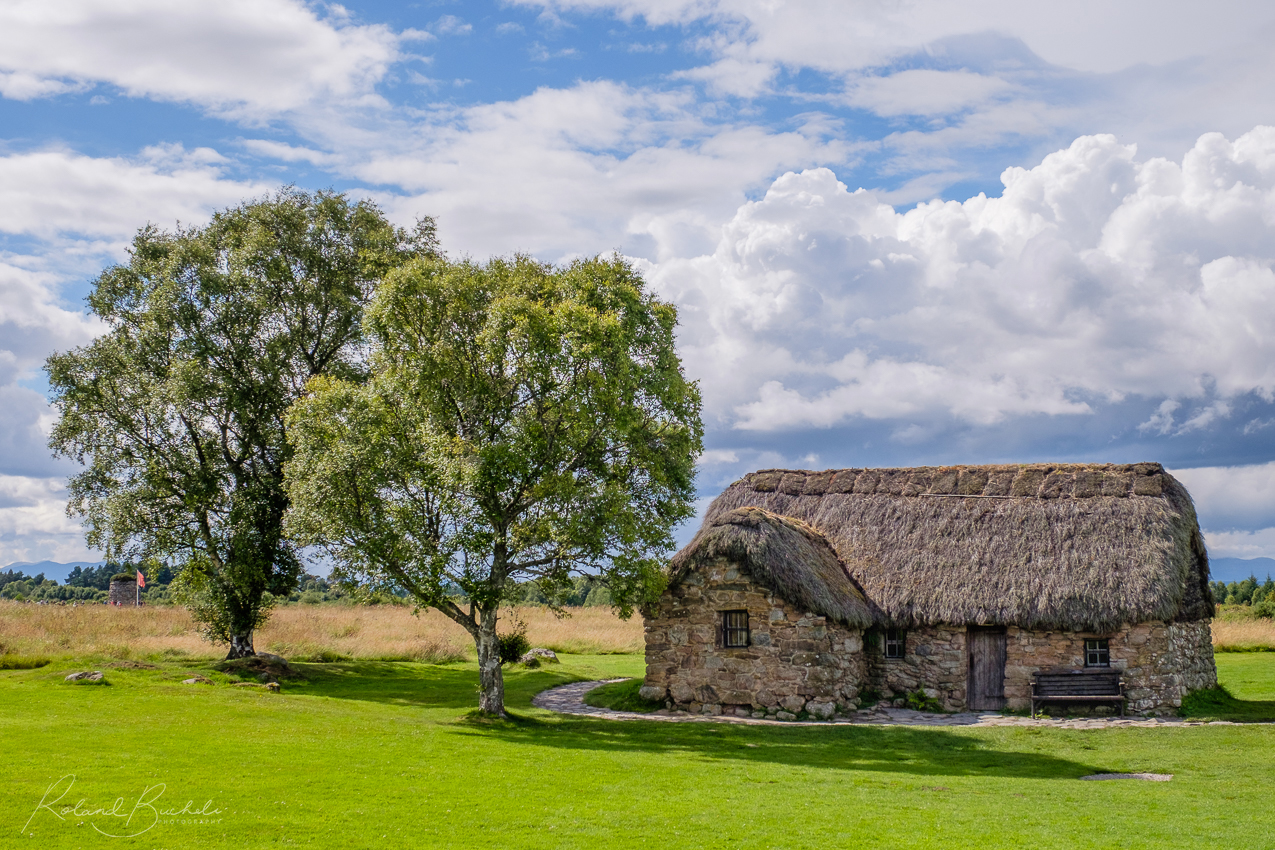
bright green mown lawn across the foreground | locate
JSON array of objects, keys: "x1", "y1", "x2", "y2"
[{"x1": 0, "y1": 652, "x2": 1275, "y2": 850}]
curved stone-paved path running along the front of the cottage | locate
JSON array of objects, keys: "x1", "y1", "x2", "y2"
[{"x1": 532, "y1": 678, "x2": 1253, "y2": 729}]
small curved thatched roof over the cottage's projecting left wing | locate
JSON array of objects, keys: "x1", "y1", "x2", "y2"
[{"x1": 669, "y1": 507, "x2": 873, "y2": 628}]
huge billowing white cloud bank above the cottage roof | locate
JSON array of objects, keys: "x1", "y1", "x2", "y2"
[{"x1": 648, "y1": 127, "x2": 1275, "y2": 433}]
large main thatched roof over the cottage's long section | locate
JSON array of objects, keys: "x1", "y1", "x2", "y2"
[{"x1": 705, "y1": 464, "x2": 1214, "y2": 632}]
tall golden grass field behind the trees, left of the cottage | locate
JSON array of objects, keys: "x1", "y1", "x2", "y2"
[{"x1": 0, "y1": 600, "x2": 643, "y2": 663}]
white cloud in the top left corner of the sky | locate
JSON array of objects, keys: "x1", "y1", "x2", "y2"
[{"x1": 0, "y1": 0, "x2": 402, "y2": 117}]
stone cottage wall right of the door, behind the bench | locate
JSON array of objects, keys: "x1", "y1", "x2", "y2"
[{"x1": 1005, "y1": 621, "x2": 1218, "y2": 715}]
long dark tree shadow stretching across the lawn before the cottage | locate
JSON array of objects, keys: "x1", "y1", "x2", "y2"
[{"x1": 456, "y1": 716, "x2": 1103, "y2": 779}]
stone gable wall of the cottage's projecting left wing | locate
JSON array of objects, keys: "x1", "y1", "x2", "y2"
[{"x1": 641, "y1": 559, "x2": 866, "y2": 719}]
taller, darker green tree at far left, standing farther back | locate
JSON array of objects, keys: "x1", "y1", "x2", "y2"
[{"x1": 46, "y1": 189, "x2": 436, "y2": 658}]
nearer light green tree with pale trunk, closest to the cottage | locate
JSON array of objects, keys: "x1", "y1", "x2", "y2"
[{"x1": 287, "y1": 251, "x2": 703, "y2": 715}]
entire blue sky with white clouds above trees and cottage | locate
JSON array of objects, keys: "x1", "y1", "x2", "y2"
[{"x1": 0, "y1": 0, "x2": 1275, "y2": 565}]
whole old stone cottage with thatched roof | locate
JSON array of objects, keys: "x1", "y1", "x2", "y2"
[{"x1": 644, "y1": 464, "x2": 1216, "y2": 715}]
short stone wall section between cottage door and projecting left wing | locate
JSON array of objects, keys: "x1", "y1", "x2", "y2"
[{"x1": 868, "y1": 626, "x2": 968, "y2": 711}]
